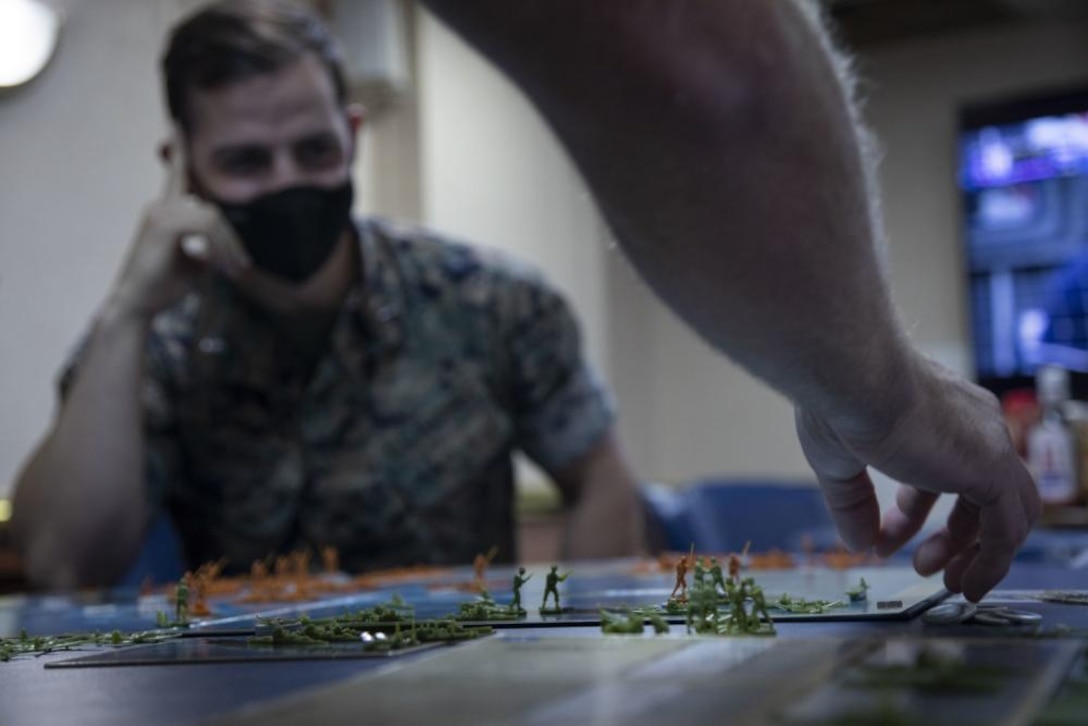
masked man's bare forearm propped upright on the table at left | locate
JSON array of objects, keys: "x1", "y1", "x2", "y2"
[{"x1": 12, "y1": 306, "x2": 153, "y2": 589}]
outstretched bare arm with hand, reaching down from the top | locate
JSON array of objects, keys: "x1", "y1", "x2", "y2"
[{"x1": 419, "y1": 0, "x2": 1039, "y2": 599}]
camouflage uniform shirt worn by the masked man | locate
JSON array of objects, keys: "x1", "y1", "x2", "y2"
[{"x1": 62, "y1": 220, "x2": 613, "y2": 570}]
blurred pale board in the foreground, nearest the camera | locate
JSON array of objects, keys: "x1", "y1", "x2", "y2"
[{"x1": 205, "y1": 631, "x2": 1084, "y2": 726}]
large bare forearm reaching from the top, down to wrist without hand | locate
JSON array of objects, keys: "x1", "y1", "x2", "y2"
[{"x1": 428, "y1": 0, "x2": 913, "y2": 428}]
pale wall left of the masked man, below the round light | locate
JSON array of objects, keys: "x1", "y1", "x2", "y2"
[{"x1": 0, "y1": 0, "x2": 173, "y2": 495}]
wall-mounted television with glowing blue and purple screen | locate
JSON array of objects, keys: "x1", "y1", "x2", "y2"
[{"x1": 959, "y1": 87, "x2": 1088, "y2": 397}]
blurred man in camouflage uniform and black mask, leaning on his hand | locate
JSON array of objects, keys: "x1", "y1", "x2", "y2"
[{"x1": 13, "y1": 0, "x2": 638, "y2": 588}]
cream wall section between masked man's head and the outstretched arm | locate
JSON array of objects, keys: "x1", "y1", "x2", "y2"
[{"x1": 417, "y1": 13, "x2": 607, "y2": 374}]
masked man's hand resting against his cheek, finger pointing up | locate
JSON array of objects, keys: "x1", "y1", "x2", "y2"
[{"x1": 111, "y1": 131, "x2": 251, "y2": 319}]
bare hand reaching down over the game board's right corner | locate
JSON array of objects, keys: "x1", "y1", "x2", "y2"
[{"x1": 796, "y1": 358, "x2": 1041, "y2": 602}]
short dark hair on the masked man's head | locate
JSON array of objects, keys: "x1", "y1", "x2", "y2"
[{"x1": 162, "y1": 0, "x2": 347, "y2": 130}]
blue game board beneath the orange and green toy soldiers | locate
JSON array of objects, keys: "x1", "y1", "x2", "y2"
[{"x1": 0, "y1": 561, "x2": 947, "y2": 636}]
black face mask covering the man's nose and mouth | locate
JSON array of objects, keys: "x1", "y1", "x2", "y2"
[{"x1": 215, "y1": 180, "x2": 355, "y2": 283}]
